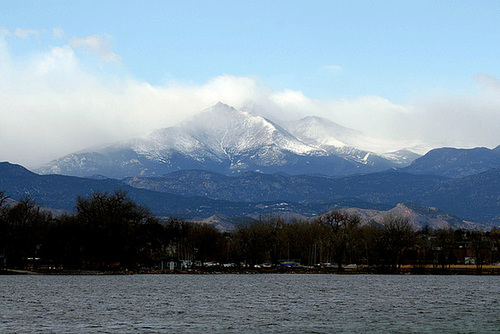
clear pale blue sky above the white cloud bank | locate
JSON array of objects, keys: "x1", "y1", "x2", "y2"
[{"x1": 4, "y1": 1, "x2": 500, "y2": 101}]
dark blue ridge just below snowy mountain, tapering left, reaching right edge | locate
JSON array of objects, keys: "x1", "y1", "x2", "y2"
[{"x1": 124, "y1": 167, "x2": 500, "y2": 222}]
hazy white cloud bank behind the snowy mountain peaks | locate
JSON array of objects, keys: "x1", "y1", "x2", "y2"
[{"x1": 0, "y1": 28, "x2": 500, "y2": 166}]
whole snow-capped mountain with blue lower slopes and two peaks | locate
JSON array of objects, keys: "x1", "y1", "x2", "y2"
[{"x1": 38, "y1": 103, "x2": 418, "y2": 178}]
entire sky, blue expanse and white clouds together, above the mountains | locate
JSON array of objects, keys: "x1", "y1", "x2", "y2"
[{"x1": 0, "y1": 0, "x2": 500, "y2": 164}]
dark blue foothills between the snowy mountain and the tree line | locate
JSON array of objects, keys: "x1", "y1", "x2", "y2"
[{"x1": 0, "y1": 163, "x2": 500, "y2": 227}]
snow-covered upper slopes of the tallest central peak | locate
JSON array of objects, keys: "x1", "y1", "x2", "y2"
[{"x1": 133, "y1": 102, "x2": 318, "y2": 159}]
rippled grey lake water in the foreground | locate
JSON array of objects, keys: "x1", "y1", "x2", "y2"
[{"x1": 0, "y1": 274, "x2": 500, "y2": 334}]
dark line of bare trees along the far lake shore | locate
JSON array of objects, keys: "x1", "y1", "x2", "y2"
[{"x1": 0, "y1": 191, "x2": 500, "y2": 272}]
